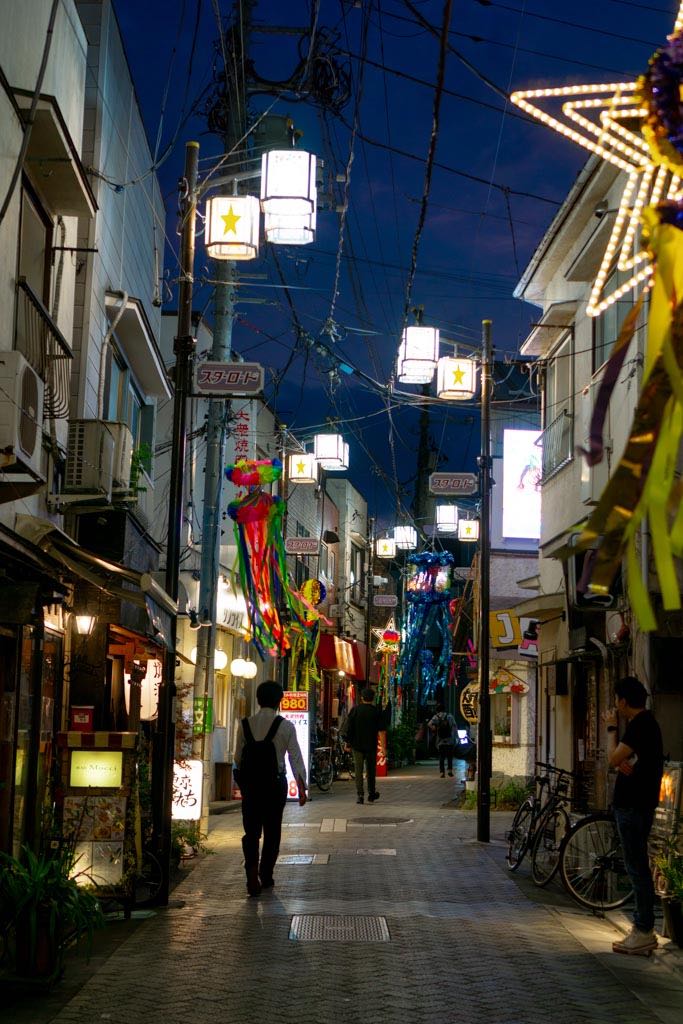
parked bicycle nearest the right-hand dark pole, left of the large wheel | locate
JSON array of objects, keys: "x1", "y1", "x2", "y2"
[{"x1": 506, "y1": 761, "x2": 572, "y2": 885}]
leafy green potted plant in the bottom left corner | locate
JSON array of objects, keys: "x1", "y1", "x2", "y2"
[{"x1": 0, "y1": 845, "x2": 104, "y2": 981}]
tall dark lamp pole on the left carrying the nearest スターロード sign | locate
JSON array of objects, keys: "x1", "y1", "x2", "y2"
[{"x1": 152, "y1": 142, "x2": 200, "y2": 905}]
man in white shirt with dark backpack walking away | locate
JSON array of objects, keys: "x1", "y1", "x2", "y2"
[{"x1": 233, "y1": 680, "x2": 306, "y2": 896}]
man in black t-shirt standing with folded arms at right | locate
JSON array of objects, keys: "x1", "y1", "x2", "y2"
[{"x1": 605, "y1": 676, "x2": 664, "y2": 953}]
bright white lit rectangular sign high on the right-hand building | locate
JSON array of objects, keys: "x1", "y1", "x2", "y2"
[{"x1": 503, "y1": 430, "x2": 542, "y2": 541}]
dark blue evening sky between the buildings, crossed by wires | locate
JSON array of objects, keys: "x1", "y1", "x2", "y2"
[{"x1": 115, "y1": 0, "x2": 678, "y2": 515}]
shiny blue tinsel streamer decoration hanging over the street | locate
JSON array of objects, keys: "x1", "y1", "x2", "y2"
[{"x1": 397, "y1": 551, "x2": 454, "y2": 697}]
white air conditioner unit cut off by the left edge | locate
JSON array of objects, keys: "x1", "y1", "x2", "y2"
[{"x1": 0, "y1": 352, "x2": 45, "y2": 480}]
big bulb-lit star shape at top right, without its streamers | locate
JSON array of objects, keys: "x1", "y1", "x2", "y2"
[{"x1": 510, "y1": 2, "x2": 683, "y2": 316}]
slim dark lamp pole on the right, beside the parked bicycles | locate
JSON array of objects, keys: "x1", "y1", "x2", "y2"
[{"x1": 477, "y1": 321, "x2": 492, "y2": 843}]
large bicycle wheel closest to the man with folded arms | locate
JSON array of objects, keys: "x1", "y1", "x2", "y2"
[{"x1": 560, "y1": 814, "x2": 633, "y2": 910}]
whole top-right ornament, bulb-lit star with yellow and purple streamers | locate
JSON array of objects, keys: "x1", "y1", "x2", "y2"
[{"x1": 511, "y1": 3, "x2": 683, "y2": 631}]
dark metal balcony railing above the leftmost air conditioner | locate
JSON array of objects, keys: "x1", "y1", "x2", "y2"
[{"x1": 14, "y1": 278, "x2": 74, "y2": 420}]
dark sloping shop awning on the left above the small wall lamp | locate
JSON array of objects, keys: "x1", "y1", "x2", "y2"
[{"x1": 15, "y1": 515, "x2": 178, "y2": 647}]
